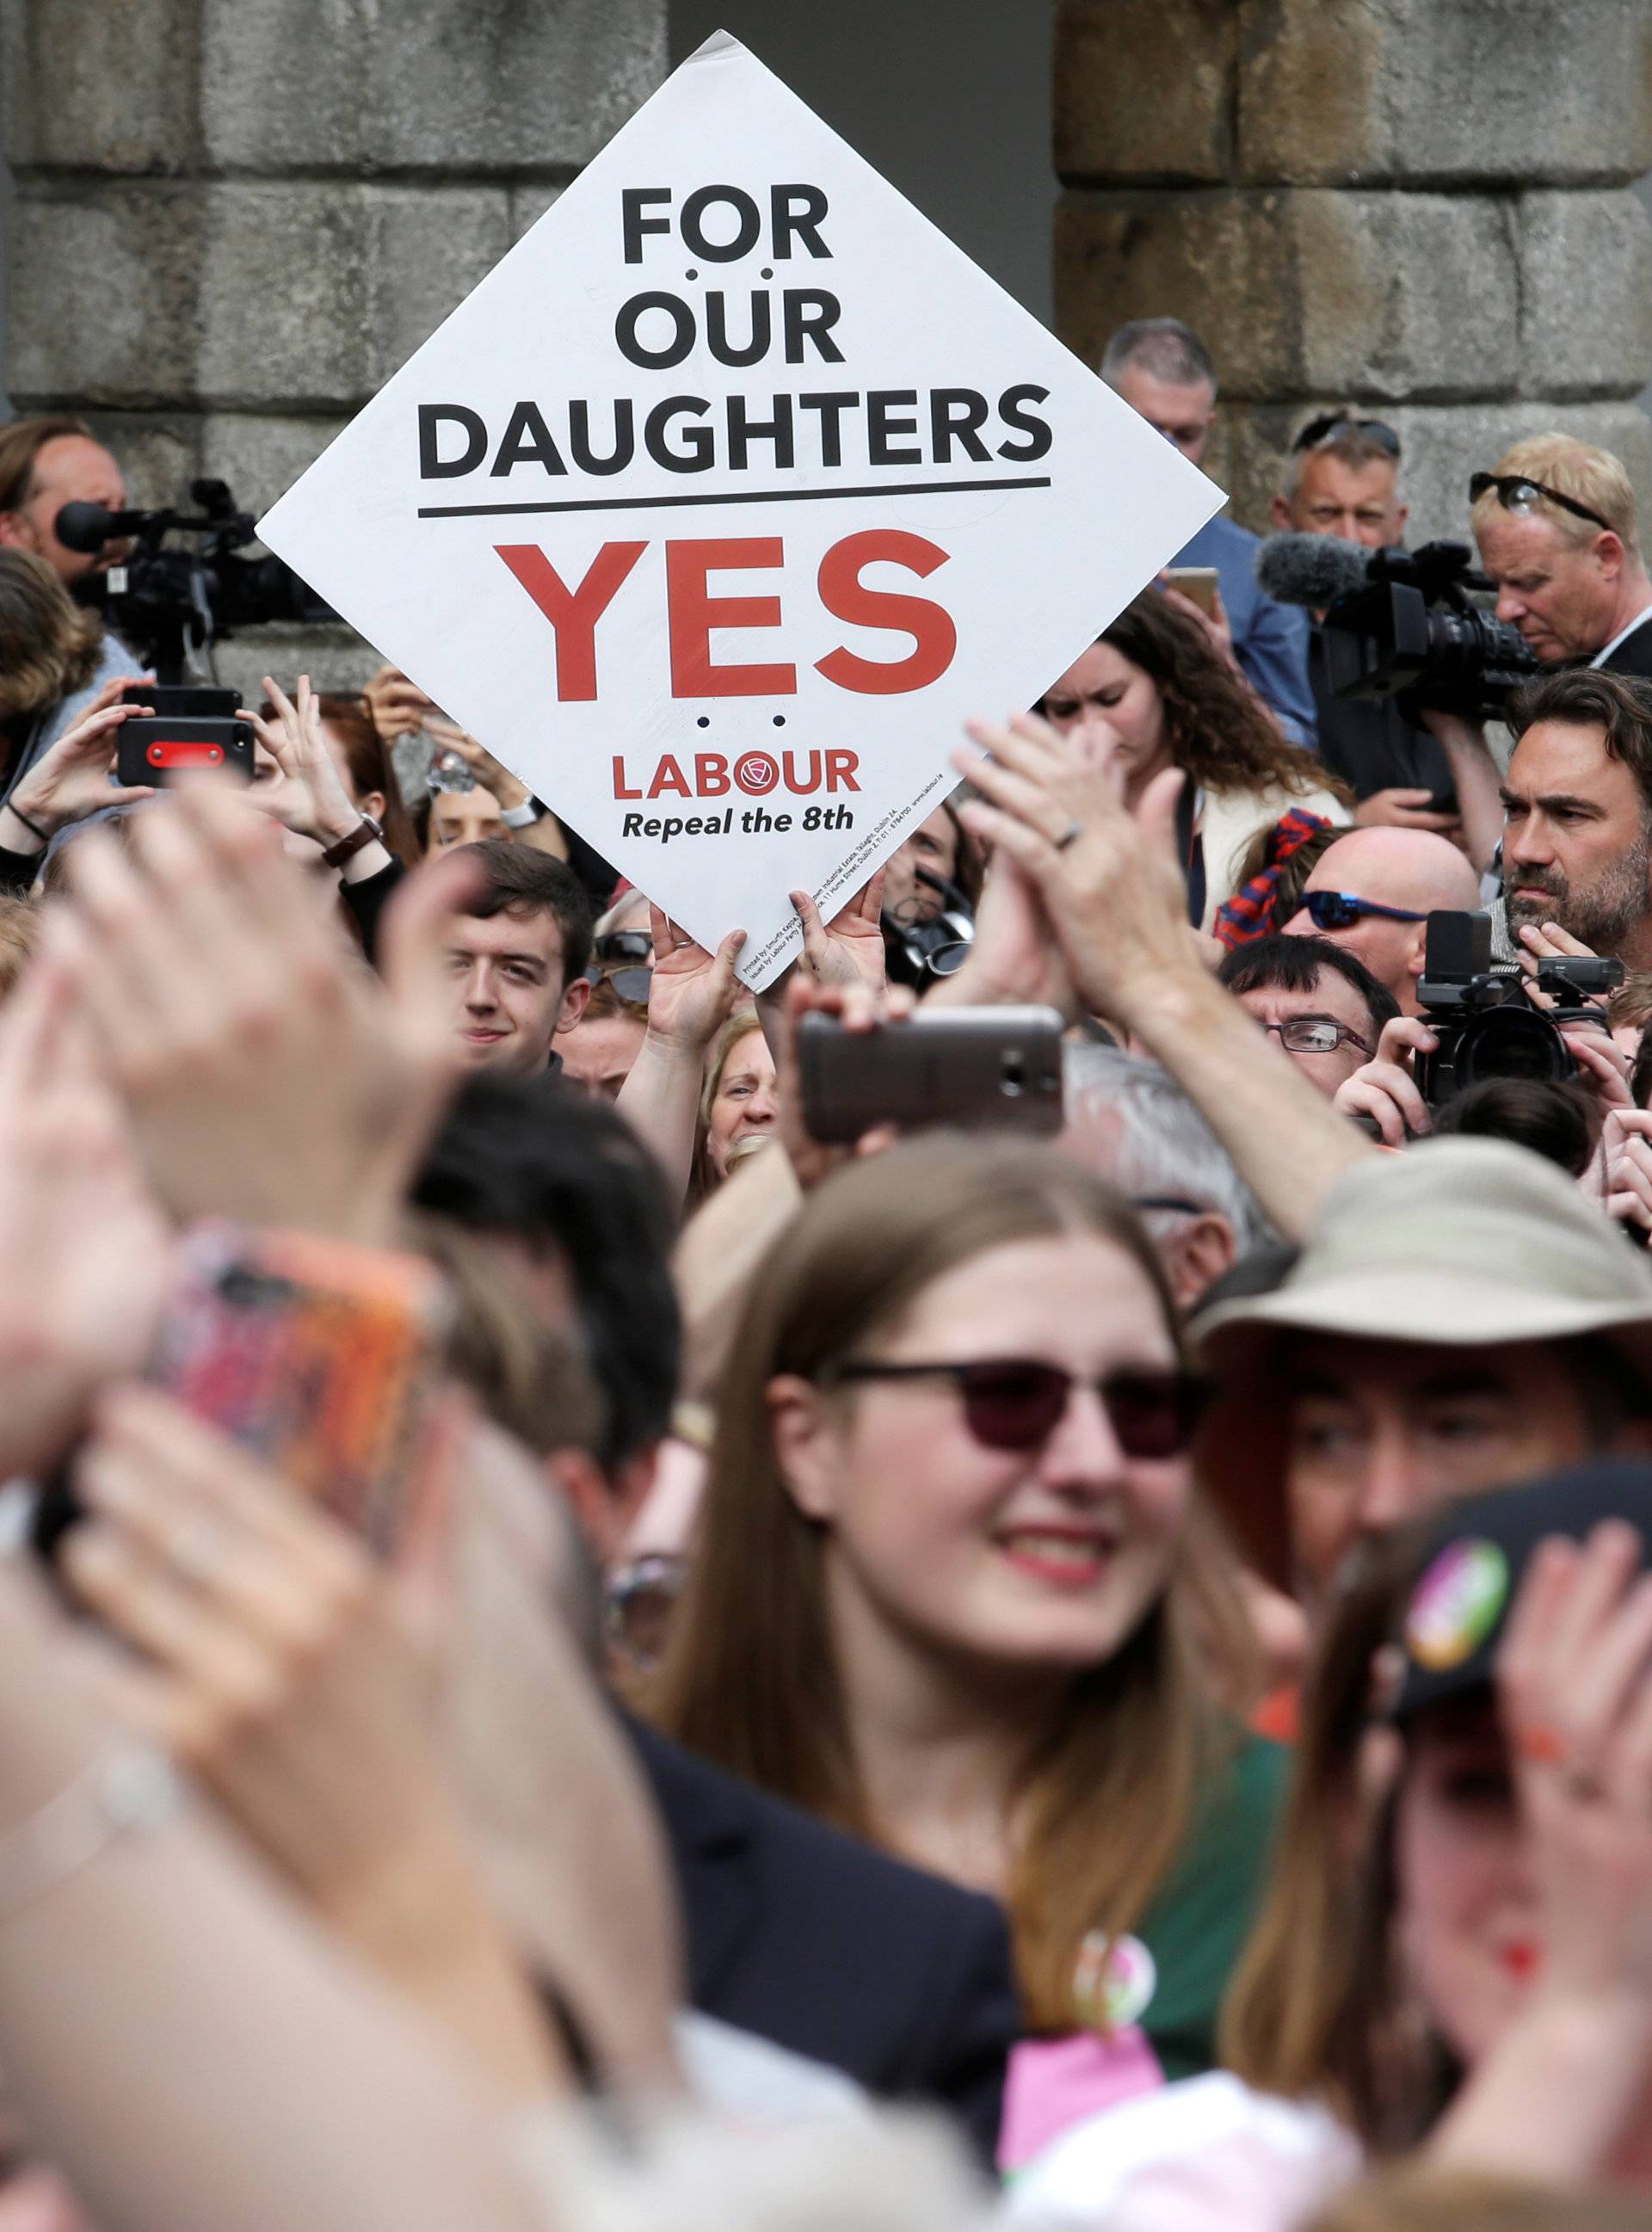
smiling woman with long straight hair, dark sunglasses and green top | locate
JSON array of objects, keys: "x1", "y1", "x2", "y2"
[{"x1": 654, "y1": 1134, "x2": 1279, "y2": 2163}]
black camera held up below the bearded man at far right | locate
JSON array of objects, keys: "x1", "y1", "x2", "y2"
[{"x1": 1415, "y1": 909, "x2": 1623, "y2": 1107}]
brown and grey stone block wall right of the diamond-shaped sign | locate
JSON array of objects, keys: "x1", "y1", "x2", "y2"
[{"x1": 1056, "y1": 0, "x2": 1652, "y2": 538}]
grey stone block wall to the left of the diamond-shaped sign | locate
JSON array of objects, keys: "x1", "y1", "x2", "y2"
[{"x1": 0, "y1": 0, "x2": 668, "y2": 687}]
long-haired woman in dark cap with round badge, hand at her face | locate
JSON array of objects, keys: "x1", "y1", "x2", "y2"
[{"x1": 1018, "y1": 1459, "x2": 1652, "y2": 2232}]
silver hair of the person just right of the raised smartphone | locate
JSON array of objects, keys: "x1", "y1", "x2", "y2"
[{"x1": 1060, "y1": 1042, "x2": 1275, "y2": 1255}]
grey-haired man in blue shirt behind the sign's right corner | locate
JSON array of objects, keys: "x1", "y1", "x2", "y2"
[{"x1": 1100, "y1": 317, "x2": 1315, "y2": 750}]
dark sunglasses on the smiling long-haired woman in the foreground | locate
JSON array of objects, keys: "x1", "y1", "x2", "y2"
[{"x1": 833, "y1": 1357, "x2": 1208, "y2": 1458}]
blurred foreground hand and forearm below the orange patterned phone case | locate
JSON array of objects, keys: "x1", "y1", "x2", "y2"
[{"x1": 63, "y1": 1386, "x2": 556, "y2": 2093}]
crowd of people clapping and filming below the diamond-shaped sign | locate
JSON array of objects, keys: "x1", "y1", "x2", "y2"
[{"x1": 0, "y1": 287, "x2": 1652, "y2": 2232}]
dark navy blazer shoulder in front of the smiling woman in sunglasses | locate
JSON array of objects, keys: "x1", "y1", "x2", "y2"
[{"x1": 627, "y1": 1721, "x2": 1020, "y2": 2161}]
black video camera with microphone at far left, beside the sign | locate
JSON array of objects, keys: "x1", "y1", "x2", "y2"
[{"x1": 53, "y1": 480, "x2": 337, "y2": 683}]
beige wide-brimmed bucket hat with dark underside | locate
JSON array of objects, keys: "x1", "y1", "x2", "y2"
[{"x1": 1190, "y1": 1138, "x2": 1652, "y2": 1585}]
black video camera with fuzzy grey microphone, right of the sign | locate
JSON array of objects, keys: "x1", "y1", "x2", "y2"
[{"x1": 1257, "y1": 536, "x2": 1540, "y2": 725}]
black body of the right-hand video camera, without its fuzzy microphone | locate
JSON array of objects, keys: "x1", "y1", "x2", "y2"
[{"x1": 1324, "y1": 542, "x2": 1540, "y2": 725}]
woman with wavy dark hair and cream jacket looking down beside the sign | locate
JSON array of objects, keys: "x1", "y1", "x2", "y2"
[{"x1": 1038, "y1": 589, "x2": 1353, "y2": 931}]
